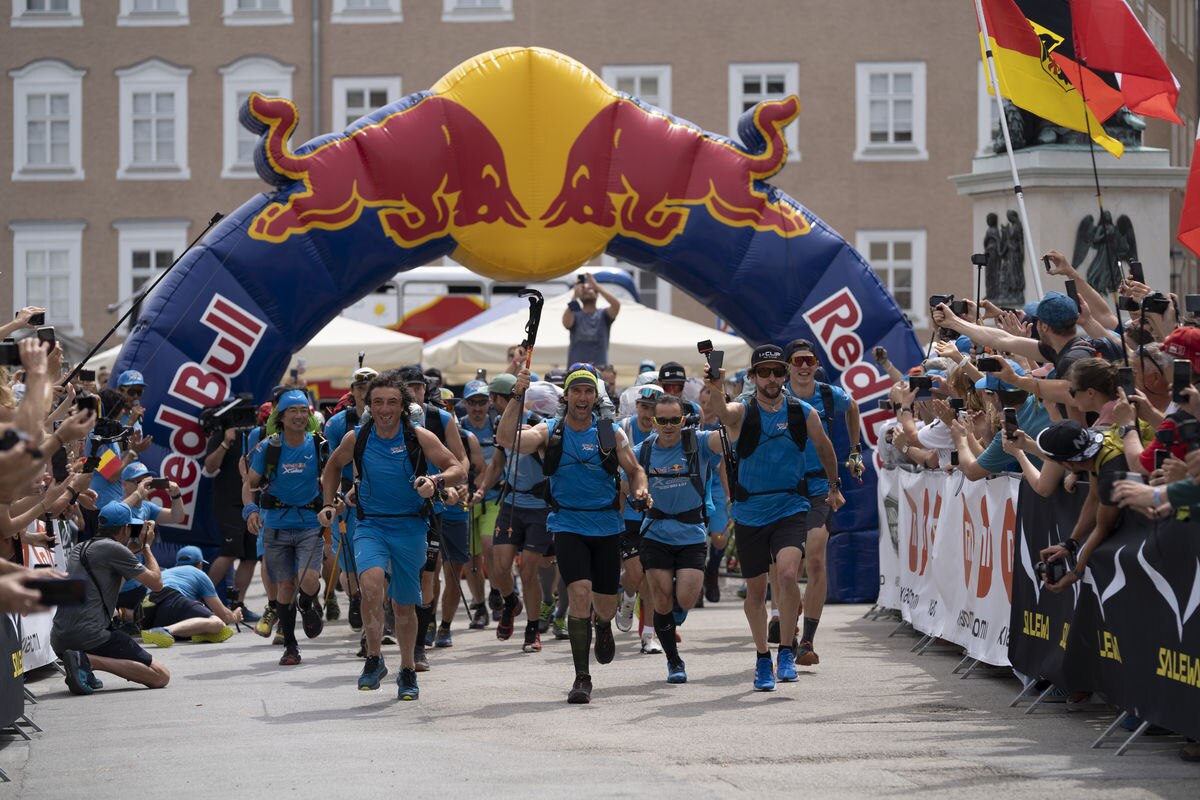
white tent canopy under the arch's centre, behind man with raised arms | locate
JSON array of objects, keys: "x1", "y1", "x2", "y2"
[{"x1": 425, "y1": 291, "x2": 751, "y2": 386}]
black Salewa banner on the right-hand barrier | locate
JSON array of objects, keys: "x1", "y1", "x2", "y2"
[{"x1": 1008, "y1": 486, "x2": 1200, "y2": 739}]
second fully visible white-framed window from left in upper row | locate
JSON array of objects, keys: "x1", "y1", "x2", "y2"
[{"x1": 116, "y1": 59, "x2": 192, "y2": 180}]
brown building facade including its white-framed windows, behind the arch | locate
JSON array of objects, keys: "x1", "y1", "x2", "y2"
[{"x1": 0, "y1": 0, "x2": 1198, "y2": 341}]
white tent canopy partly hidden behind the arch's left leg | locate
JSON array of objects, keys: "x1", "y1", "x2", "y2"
[{"x1": 88, "y1": 317, "x2": 424, "y2": 385}]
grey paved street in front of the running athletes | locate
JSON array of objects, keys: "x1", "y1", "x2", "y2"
[{"x1": 0, "y1": 584, "x2": 1200, "y2": 800}]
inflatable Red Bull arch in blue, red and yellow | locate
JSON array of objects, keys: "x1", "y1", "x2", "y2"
[{"x1": 113, "y1": 48, "x2": 920, "y2": 545}]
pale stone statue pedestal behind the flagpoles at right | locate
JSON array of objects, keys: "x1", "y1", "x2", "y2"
[{"x1": 950, "y1": 144, "x2": 1188, "y2": 300}]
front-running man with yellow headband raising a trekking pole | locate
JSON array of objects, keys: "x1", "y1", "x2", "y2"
[{"x1": 496, "y1": 368, "x2": 650, "y2": 703}]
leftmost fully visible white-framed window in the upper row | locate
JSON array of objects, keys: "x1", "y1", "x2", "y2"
[{"x1": 8, "y1": 60, "x2": 86, "y2": 181}]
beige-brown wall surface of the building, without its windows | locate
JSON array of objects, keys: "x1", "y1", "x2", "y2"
[{"x1": 0, "y1": 0, "x2": 1196, "y2": 341}]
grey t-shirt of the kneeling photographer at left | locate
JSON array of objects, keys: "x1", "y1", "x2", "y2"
[{"x1": 50, "y1": 539, "x2": 145, "y2": 652}]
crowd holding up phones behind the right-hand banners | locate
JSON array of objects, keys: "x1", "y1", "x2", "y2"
[{"x1": 875, "y1": 251, "x2": 1200, "y2": 760}]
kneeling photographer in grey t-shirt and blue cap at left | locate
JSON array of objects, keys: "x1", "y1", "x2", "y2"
[{"x1": 50, "y1": 503, "x2": 170, "y2": 694}]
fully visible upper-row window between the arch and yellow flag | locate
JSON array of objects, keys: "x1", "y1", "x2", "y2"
[{"x1": 854, "y1": 61, "x2": 929, "y2": 161}]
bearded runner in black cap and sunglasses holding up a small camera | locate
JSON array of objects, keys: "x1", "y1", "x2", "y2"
[{"x1": 706, "y1": 344, "x2": 845, "y2": 691}]
